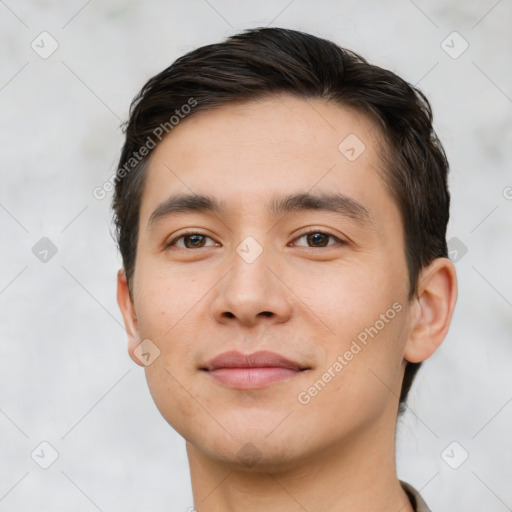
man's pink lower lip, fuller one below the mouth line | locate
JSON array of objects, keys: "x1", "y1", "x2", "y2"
[{"x1": 208, "y1": 367, "x2": 301, "y2": 389}]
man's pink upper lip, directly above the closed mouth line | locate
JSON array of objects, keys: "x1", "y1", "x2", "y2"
[{"x1": 202, "y1": 350, "x2": 305, "y2": 371}]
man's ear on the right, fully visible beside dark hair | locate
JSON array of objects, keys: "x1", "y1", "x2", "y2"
[{"x1": 404, "y1": 258, "x2": 457, "y2": 363}]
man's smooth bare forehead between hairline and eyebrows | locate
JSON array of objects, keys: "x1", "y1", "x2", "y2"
[{"x1": 140, "y1": 95, "x2": 392, "y2": 230}]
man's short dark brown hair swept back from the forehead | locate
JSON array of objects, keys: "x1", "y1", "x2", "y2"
[{"x1": 112, "y1": 28, "x2": 450, "y2": 412}]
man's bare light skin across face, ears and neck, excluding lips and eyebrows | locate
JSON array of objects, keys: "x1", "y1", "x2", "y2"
[{"x1": 117, "y1": 95, "x2": 457, "y2": 512}]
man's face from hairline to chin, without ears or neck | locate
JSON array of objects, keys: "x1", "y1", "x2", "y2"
[{"x1": 124, "y1": 96, "x2": 411, "y2": 467}]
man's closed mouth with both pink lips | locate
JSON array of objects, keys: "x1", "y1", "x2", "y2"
[{"x1": 200, "y1": 351, "x2": 310, "y2": 389}]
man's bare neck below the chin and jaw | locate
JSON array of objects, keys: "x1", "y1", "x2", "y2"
[{"x1": 187, "y1": 412, "x2": 414, "y2": 512}]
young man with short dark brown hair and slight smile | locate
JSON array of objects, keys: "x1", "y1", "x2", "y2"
[{"x1": 113, "y1": 28, "x2": 457, "y2": 512}]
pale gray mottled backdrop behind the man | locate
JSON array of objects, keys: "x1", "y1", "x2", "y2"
[{"x1": 0, "y1": 0, "x2": 512, "y2": 512}]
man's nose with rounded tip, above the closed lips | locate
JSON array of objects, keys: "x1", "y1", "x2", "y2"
[{"x1": 211, "y1": 241, "x2": 293, "y2": 327}]
